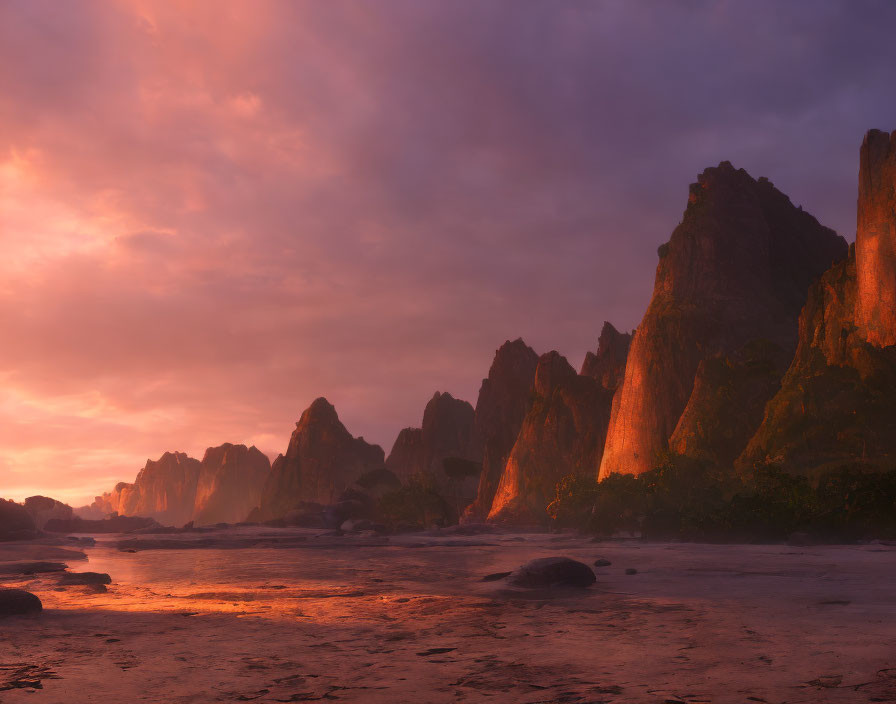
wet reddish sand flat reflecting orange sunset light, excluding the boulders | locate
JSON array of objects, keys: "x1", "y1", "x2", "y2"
[{"x1": 0, "y1": 529, "x2": 896, "y2": 704}]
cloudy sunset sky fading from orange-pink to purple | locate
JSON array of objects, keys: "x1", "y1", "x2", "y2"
[{"x1": 0, "y1": 0, "x2": 896, "y2": 505}]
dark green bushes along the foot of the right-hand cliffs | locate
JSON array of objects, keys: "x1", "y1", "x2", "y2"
[{"x1": 548, "y1": 454, "x2": 896, "y2": 542}]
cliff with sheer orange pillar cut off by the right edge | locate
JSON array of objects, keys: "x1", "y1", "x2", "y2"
[{"x1": 738, "y1": 130, "x2": 896, "y2": 474}]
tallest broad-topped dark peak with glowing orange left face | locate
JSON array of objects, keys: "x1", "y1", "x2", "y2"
[{"x1": 600, "y1": 162, "x2": 847, "y2": 477}]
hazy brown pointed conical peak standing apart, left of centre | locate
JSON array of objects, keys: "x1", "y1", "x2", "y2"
[{"x1": 252, "y1": 398, "x2": 384, "y2": 520}]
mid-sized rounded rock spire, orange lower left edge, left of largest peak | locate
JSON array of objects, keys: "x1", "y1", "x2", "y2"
[{"x1": 488, "y1": 352, "x2": 612, "y2": 523}]
